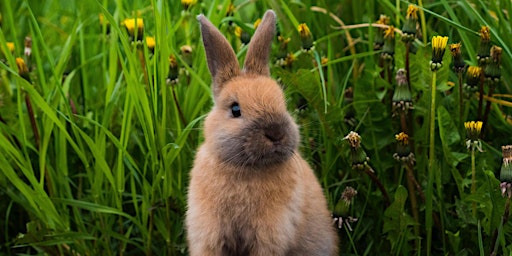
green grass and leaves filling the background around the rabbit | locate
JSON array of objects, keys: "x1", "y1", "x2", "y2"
[{"x1": 0, "y1": 0, "x2": 512, "y2": 255}]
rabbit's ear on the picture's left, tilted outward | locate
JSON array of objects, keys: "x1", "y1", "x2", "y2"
[{"x1": 197, "y1": 14, "x2": 240, "y2": 98}]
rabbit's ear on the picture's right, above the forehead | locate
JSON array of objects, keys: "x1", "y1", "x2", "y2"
[{"x1": 244, "y1": 10, "x2": 276, "y2": 76}]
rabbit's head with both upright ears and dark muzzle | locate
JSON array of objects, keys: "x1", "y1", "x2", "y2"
[{"x1": 198, "y1": 11, "x2": 299, "y2": 169}]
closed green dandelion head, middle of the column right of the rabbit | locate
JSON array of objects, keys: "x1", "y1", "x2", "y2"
[{"x1": 392, "y1": 68, "x2": 413, "y2": 115}]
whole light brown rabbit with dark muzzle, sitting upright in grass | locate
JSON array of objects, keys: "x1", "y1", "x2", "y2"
[{"x1": 186, "y1": 11, "x2": 338, "y2": 256}]
